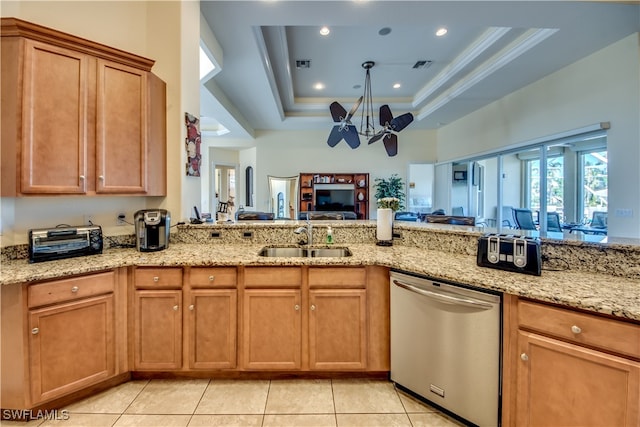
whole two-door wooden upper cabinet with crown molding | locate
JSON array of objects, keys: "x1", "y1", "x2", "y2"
[{"x1": 0, "y1": 18, "x2": 166, "y2": 197}]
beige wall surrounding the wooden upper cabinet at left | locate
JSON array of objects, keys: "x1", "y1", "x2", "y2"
[{"x1": 0, "y1": 0, "x2": 200, "y2": 246}]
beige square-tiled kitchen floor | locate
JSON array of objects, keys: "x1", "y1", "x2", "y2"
[{"x1": 1, "y1": 379, "x2": 460, "y2": 427}]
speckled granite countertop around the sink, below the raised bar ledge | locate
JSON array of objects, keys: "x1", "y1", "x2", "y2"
[{"x1": 0, "y1": 243, "x2": 640, "y2": 321}]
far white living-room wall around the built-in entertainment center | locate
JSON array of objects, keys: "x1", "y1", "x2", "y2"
[{"x1": 235, "y1": 129, "x2": 436, "y2": 217}]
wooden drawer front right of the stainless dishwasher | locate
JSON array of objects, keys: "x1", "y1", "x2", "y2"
[{"x1": 518, "y1": 301, "x2": 640, "y2": 358}]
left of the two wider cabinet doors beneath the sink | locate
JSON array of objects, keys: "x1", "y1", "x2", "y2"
[{"x1": 242, "y1": 289, "x2": 302, "y2": 369}]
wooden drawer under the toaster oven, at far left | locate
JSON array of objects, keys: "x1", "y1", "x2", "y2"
[{"x1": 27, "y1": 271, "x2": 115, "y2": 308}]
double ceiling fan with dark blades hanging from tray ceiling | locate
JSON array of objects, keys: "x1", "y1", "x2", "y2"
[{"x1": 327, "y1": 61, "x2": 413, "y2": 157}]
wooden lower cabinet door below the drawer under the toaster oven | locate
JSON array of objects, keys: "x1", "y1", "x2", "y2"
[{"x1": 29, "y1": 294, "x2": 115, "y2": 403}]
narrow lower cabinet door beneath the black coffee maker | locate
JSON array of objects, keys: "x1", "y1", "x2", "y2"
[{"x1": 134, "y1": 290, "x2": 182, "y2": 370}]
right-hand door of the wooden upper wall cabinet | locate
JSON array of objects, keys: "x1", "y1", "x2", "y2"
[{"x1": 96, "y1": 60, "x2": 148, "y2": 193}]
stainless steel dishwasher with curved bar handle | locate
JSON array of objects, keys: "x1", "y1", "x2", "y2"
[{"x1": 390, "y1": 272, "x2": 502, "y2": 427}]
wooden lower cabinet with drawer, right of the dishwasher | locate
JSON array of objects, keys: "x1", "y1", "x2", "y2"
[{"x1": 502, "y1": 295, "x2": 640, "y2": 427}]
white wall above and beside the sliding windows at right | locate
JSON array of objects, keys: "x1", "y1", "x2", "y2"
[{"x1": 437, "y1": 34, "x2": 640, "y2": 238}]
